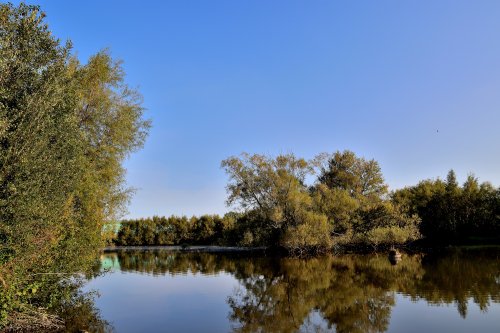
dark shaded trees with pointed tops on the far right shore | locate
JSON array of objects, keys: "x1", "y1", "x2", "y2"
[{"x1": 392, "y1": 170, "x2": 500, "y2": 243}]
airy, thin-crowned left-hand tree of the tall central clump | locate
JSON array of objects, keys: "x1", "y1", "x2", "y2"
[{"x1": 222, "y1": 154, "x2": 330, "y2": 252}]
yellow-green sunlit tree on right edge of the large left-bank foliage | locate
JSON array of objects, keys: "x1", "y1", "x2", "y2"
[{"x1": 70, "y1": 50, "x2": 150, "y2": 220}]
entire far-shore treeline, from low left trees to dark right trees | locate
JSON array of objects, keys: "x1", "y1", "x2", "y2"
[{"x1": 114, "y1": 151, "x2": 500, "y2": 253}]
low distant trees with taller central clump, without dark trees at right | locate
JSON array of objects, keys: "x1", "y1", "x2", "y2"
[{"x1": 115, "y1": 151, "x2": 420, "y2": 253}]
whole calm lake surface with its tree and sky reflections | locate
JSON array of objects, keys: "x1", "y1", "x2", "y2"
[{"x1": 87, "y1": 248, "x2": 500, "y2": 333}]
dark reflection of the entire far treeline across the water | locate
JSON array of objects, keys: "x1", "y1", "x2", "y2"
[{"x1": 107, "y1": 250, "x2": 500, "y2": 332}]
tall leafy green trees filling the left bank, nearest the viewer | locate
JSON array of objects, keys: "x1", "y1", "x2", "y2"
[{"x1": 0, "y1": 4, "x2": 149, "y2": 329}]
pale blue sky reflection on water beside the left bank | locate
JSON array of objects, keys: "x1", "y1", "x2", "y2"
[{"x1": 86, "y1": 272, "x2": 237, "y2": 333}]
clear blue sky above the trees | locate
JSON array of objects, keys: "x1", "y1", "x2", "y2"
[{"x1": 14, "y1": 0, "x2": 500, "y2": 217}]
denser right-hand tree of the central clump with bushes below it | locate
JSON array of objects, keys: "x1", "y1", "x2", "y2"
[{"x1": 311, "y1": 151, "x2": 420, "y2": 246}]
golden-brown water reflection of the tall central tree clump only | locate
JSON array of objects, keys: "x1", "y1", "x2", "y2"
[{"x1": 228, "y1": 256, "x2": 418, "y2": 332}]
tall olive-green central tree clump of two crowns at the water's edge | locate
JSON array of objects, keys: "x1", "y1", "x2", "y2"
[{"x1": 222, "y1": 151, "x2": 420, "y2": 253}]
